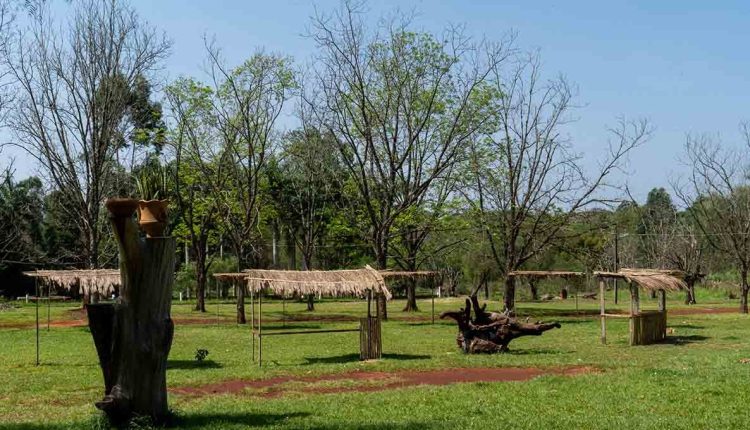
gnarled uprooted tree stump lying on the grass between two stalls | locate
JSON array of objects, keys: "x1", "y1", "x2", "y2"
[{"x1": 440, "y1": 296, "x2": 560, "y2": 354}]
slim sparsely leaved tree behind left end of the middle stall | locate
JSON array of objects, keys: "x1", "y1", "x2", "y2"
[{"x1": 206, "y1": 44, "x2": 297, "y2": 324}]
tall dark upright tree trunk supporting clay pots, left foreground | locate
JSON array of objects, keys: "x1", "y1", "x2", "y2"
[{"x1": 89, "y1": 202, "x2": 175, "y2": 422}]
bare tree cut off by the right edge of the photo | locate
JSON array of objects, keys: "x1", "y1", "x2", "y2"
[{"x1": 675, "y1": 127, "x2": 750, "y2": 313}]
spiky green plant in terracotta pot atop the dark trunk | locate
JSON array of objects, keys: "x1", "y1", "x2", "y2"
[{"x1": 135, "y1": 166, "x2": 169, "y2": 237}]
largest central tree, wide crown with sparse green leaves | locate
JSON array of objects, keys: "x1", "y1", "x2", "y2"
[{"x1": 310, "y1": 2, "x2": 508, "y2": 318}]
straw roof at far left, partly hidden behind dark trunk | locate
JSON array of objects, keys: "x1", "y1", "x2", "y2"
[{"x1": 23, "y1": 269, "x2": 121, "y2": 295}]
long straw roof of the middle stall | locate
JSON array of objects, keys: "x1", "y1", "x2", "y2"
[{"x1": 214, "y1": 266, "x2": 392, "y2": 299}]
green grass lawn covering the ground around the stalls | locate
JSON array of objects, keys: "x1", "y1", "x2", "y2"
[{"x1": 0, "y1": 292, "x2": 750, "y2": 430}]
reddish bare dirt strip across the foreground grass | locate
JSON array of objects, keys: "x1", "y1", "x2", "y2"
[{"x1": 170, "y1": 366, "x2": 597, "y2": 398}]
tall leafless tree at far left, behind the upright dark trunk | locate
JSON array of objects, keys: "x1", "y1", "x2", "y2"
[{"x1": 2, "y1": 0, "x2": 170, "y2": 267}]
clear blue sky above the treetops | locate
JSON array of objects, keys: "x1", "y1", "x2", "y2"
[{"x1": 2, "y1": 0, "x2": 750, "y2": 200}]
